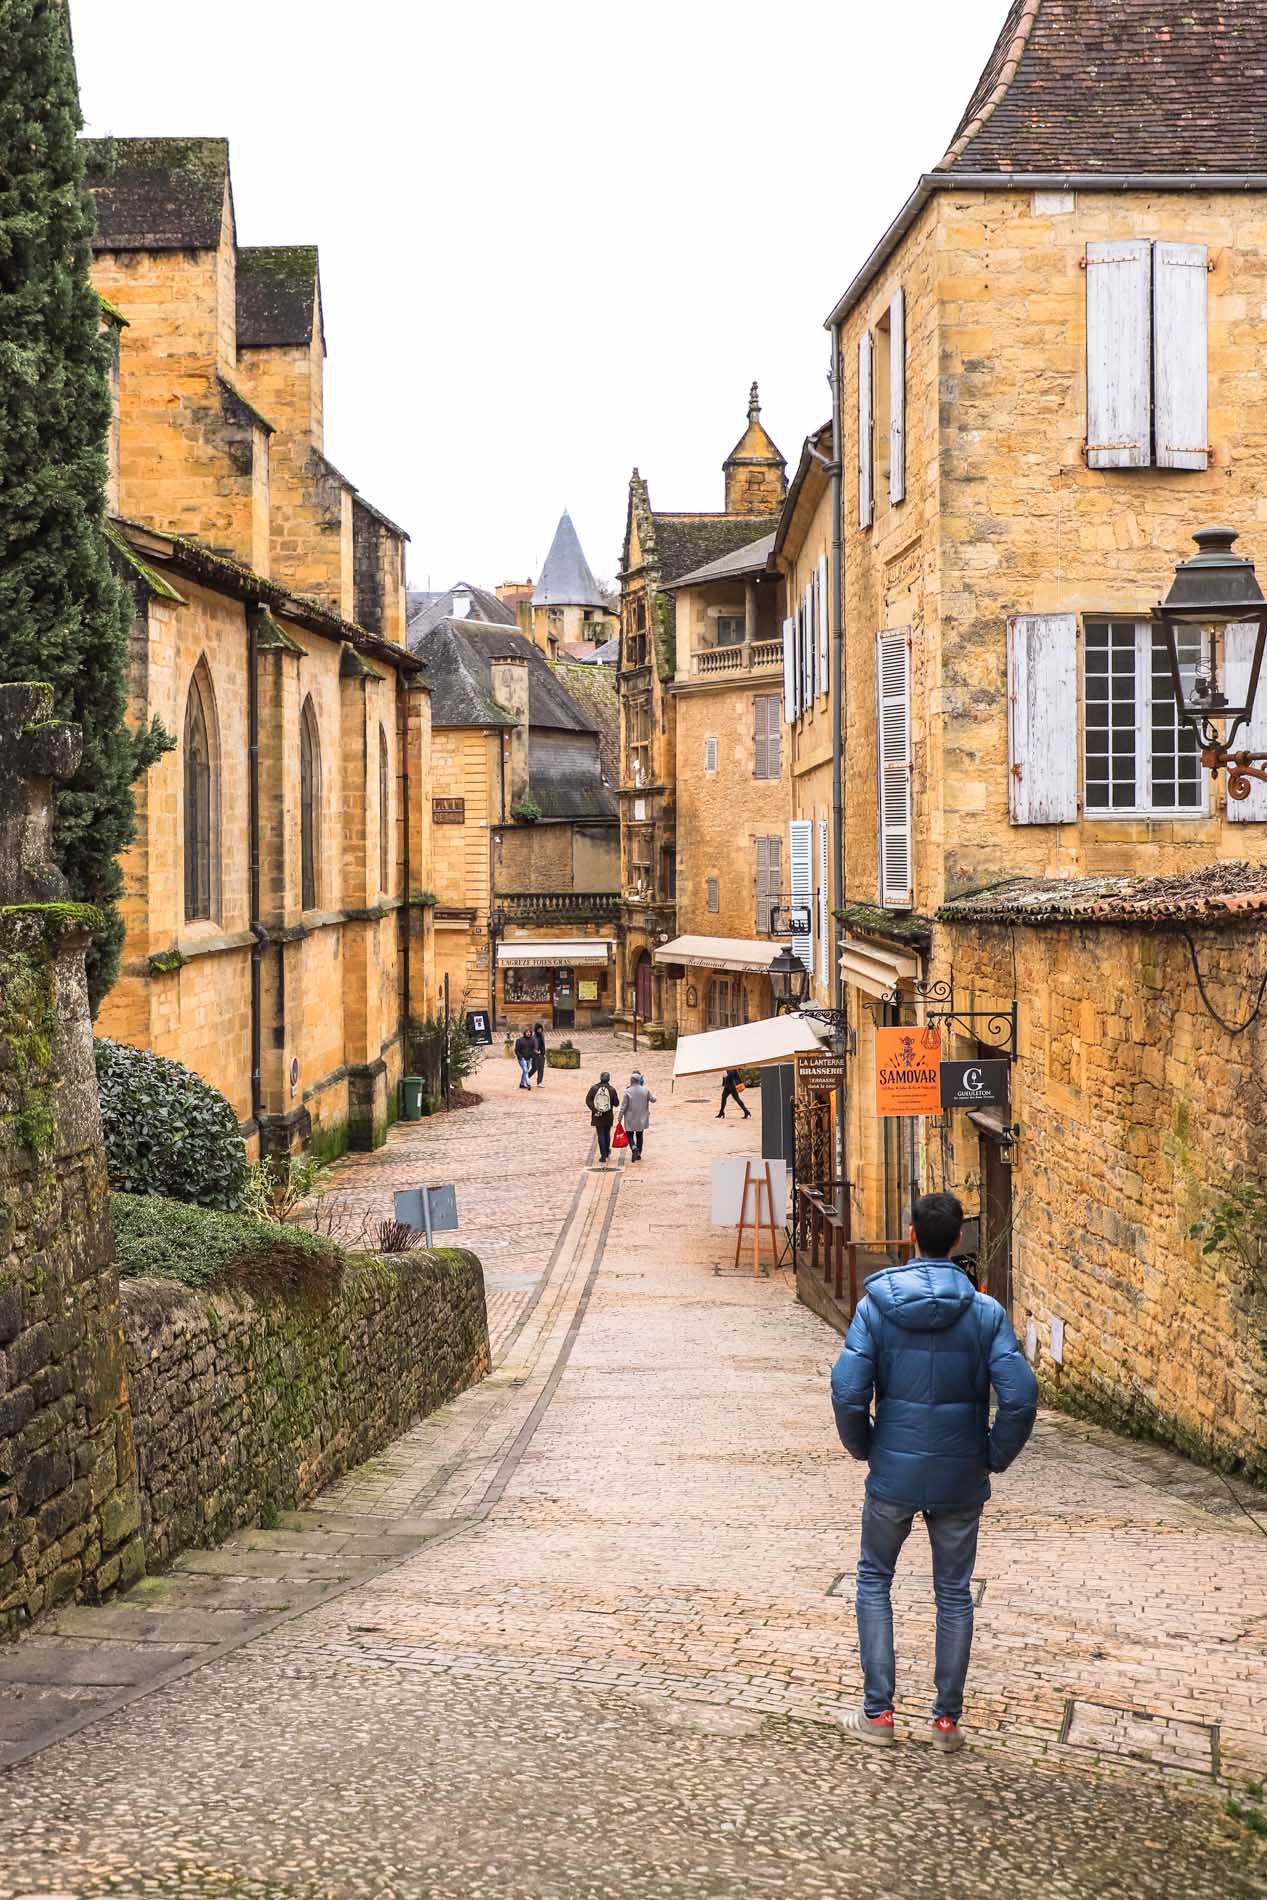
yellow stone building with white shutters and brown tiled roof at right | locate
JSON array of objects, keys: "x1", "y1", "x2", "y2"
[{"x1": 816, "y1": 0, "x2": 1267, "y2": 1467}]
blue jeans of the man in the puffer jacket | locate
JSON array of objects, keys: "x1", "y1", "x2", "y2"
[{"x1": 855, "y1": 1493, "x2": 982, "y2": 1721}]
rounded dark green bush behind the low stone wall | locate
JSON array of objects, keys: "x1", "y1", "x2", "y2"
[{"x1": 93, "y1": 1036, "x2": 247, "y2": 1208}]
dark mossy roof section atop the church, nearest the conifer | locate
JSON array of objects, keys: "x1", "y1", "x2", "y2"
[{"x1": 84, "y1": 139, "x2": 228, "y2": 251}]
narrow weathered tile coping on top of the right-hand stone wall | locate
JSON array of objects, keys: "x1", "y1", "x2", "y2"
[{"x1": 938, "y1": 859, "x2": 1267, "y2": 925}]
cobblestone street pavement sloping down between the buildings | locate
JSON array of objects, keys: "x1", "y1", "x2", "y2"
[{"x1": 0, "y1": 1037, "x2": 1267, "y2": 1900}]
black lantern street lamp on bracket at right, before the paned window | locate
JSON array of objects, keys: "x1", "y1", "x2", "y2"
[{"x1": 1153, "y1": 528, "x2": 1267, "y2": 800}]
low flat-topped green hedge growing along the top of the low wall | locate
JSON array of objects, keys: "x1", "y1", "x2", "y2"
[{"x1": 110, "y1": 1193, "x2": 346, "y2": 1292}]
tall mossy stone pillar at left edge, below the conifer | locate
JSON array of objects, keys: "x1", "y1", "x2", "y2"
[{"x1": 0, "y1": 686, "x2": 144, "y2": 1636}]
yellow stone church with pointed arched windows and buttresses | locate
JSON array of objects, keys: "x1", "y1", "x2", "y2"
[{"x1": 87, "y1": 139, "x2": 431, "y2": 1153}]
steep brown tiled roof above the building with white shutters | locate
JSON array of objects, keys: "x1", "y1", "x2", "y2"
[{"x1": 938, "y1": 0, "x2": 1267, "y2": 173}]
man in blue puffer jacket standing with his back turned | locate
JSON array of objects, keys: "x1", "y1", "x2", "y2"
[{"x1": 832, "y1": 1193, "x2": 1039, "y2": 1752}]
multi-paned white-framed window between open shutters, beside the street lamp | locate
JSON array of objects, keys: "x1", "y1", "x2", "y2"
[{"x1": 1083, "y1": 619, "x2": 1206, "y2": 817}]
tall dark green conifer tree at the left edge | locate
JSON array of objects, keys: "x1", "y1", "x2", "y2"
[{"x1": 0, "y1": 0, "x2": 169, "y2": 1009}]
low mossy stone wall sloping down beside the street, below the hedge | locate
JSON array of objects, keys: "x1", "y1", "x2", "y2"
[{"x1": 122, "y1": 1252, "x2": 488, "y2": 1568}]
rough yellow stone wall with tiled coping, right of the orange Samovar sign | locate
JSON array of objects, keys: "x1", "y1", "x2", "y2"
[{"x1": 927, "y1": 923, "x2": 1267, "y2": 1476}]
